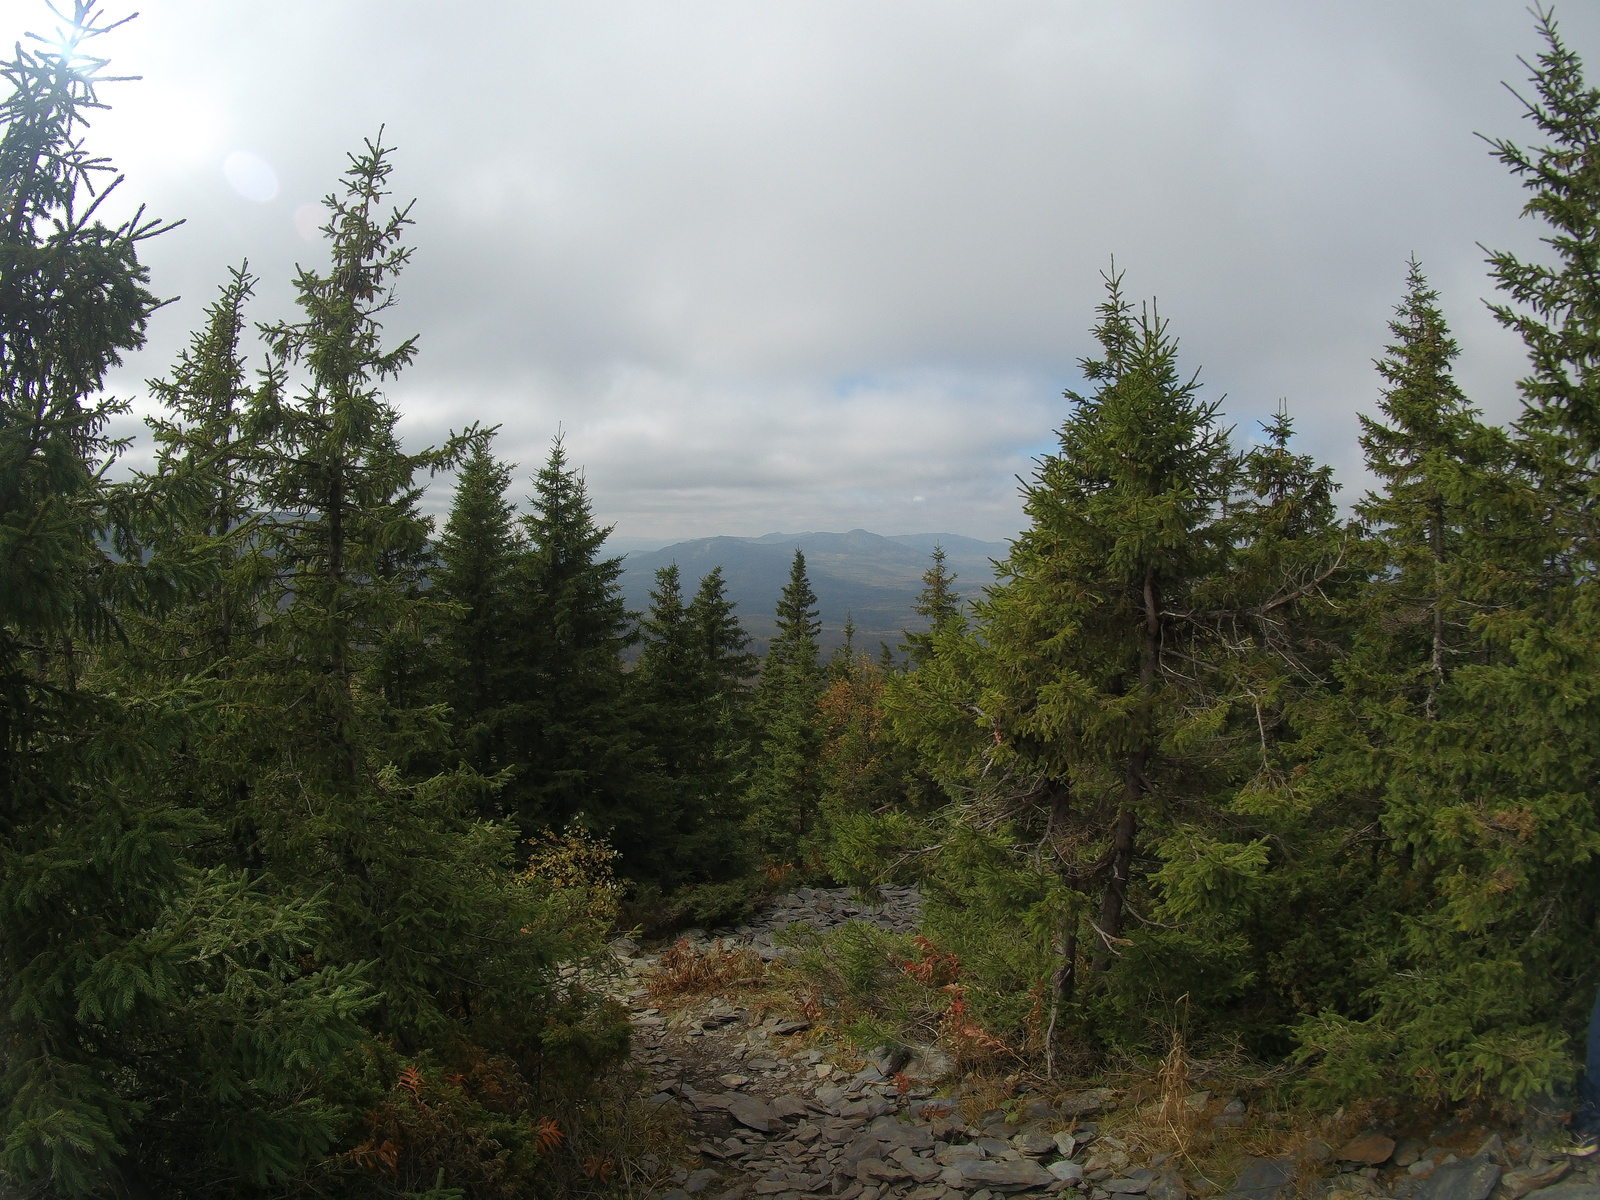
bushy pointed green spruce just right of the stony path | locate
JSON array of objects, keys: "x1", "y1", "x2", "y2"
[{"x1": 979, "y1": 275, "x2": 1235, "y2": 970}]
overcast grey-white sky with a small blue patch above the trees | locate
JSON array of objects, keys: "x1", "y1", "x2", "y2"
[{"x1": 21, "y1": 0, "x2": 1600, "y2": 541}]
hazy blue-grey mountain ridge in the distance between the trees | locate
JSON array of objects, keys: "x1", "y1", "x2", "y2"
[{"x1": 622, "y1": 530, "x2": 1010, "y2": 653}]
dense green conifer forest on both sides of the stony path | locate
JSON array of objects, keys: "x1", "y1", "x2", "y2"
[{"x1": 15, "y1": 0, "x2": 1600, "y2": 1200}]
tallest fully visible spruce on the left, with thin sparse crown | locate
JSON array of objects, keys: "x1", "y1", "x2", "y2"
[{"x1": 218, "y1": 142, "x2": 576, "y2": 1094}]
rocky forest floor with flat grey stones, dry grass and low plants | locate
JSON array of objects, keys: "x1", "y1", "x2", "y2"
[{"x1": 613, "y1": 888, "x2": 1600, "y2": 1200}]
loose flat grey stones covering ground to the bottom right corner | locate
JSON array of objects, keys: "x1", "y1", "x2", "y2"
[{"x1": 601, "y1": 888, "x2": 1600, "y2": 1200}]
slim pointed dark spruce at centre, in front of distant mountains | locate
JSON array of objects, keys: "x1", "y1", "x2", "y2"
[{"x1": 749, "y1": 550, "x2": 822, "y2": 862}]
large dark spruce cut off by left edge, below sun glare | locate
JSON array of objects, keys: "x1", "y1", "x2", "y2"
[{"x1": 0, "y1": 14, "x2": 360, "y2": 1197}]
